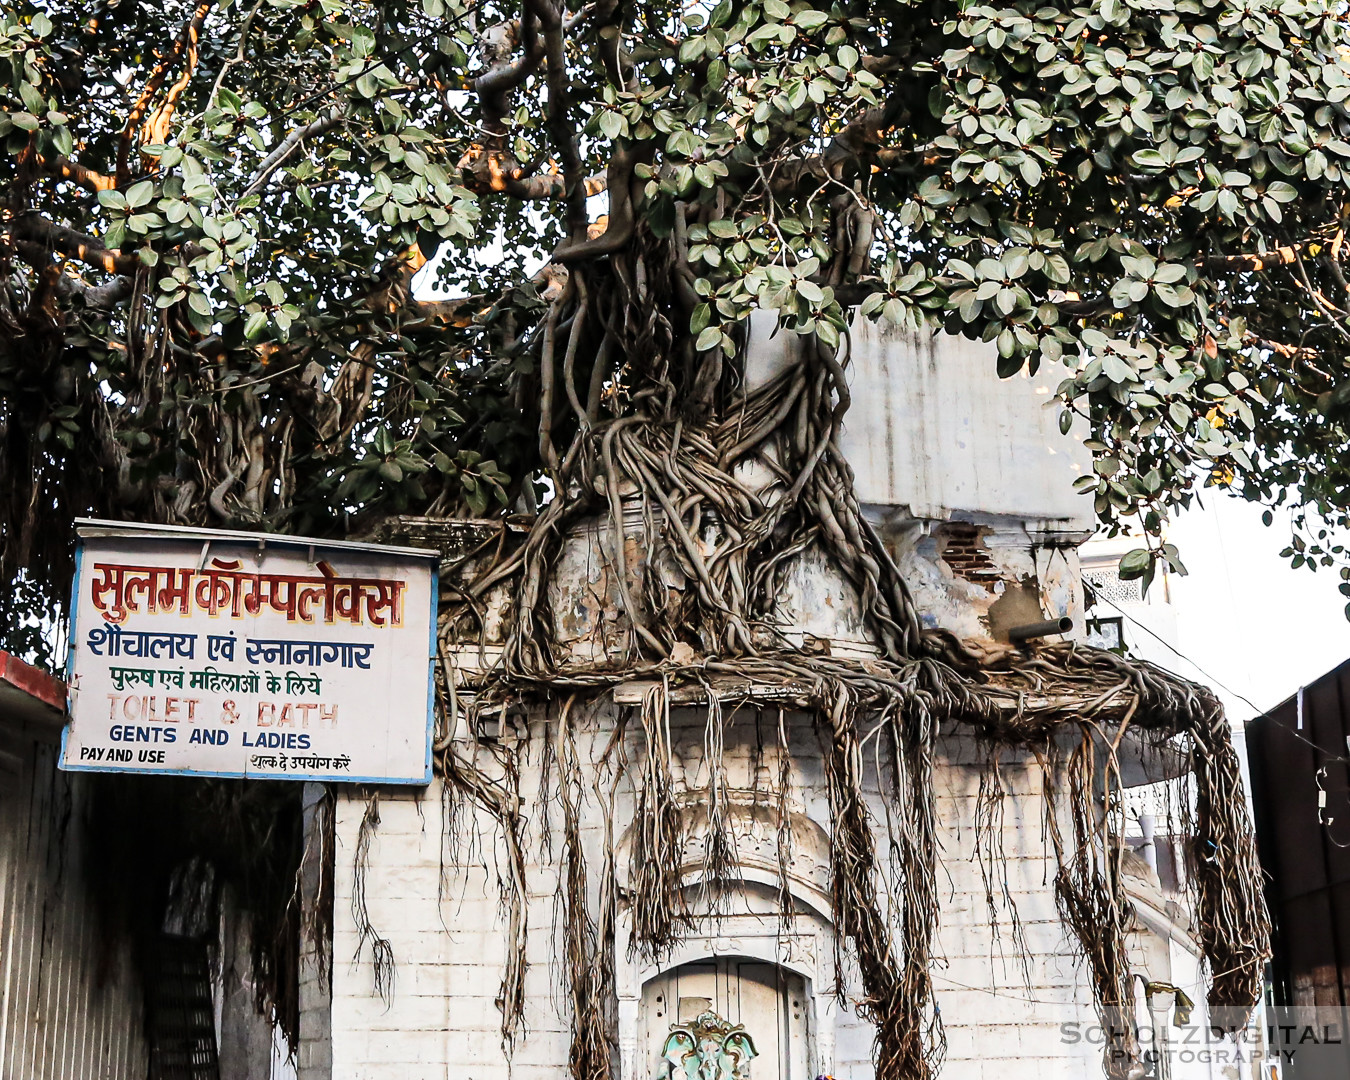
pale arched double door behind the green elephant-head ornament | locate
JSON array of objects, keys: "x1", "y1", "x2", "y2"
[{"x1": 637, "y1": 956, "x2": 813, "y2": 1080}]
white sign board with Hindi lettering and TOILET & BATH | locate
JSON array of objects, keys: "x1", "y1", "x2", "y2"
[{"x1": 61, "y1": 521, "x2": 439, "y2": 784}]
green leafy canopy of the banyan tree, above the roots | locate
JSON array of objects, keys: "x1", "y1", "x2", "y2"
[{"x1": 0, "y1": 0, "x2": 1350, "y2": 658}]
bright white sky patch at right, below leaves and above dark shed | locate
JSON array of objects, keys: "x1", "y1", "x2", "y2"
[{"x1": 1139, "y1": 489, "x2": 1350, "y2": 720}]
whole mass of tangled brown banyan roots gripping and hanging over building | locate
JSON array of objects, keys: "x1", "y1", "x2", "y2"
[{"x1": 436, "y1": 299, "x2": 1269, "y2": 1080}]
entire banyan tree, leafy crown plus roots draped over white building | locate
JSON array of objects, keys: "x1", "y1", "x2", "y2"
[{"x1": 0, "y1": 0, "x2": 1350, "y2": 1080}]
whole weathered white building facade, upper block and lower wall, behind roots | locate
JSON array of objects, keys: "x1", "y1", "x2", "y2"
[{"x1": 310, "y1": 325, "x2": 1258, "y2": 1080}]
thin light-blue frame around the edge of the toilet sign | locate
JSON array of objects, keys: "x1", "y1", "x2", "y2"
[{"x1": 57, "y1": 517, "x2": 441, "y2": 787}]
